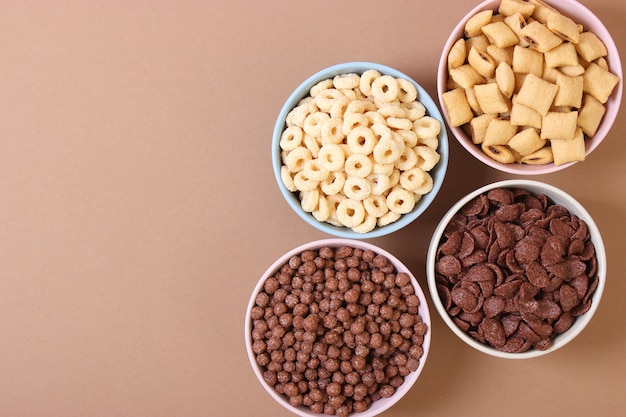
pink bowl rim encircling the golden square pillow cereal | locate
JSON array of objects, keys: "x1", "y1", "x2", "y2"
[{"x1": 437, "y1": 0, "x2": 623, "y2": 175}]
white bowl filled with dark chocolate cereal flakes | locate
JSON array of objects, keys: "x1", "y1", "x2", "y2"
[{"x1": 427, "y1": 179, "x2": 606, "y2": 359}]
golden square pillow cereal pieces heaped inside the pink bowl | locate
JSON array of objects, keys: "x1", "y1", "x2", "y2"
[{"x1": 442, "y1": 0, "x2": 620, "y2": 165}]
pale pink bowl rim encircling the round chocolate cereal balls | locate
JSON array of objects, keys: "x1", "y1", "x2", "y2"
[{"x1": 244, "y1": 238, "x2": 432, "y2": 417}]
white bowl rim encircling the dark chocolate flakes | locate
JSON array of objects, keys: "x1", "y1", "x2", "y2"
[{"x1": 426, "y1": 179, "x2": 607, "y2": 359}]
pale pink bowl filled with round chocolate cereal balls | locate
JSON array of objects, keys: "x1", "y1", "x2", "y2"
[{"x1": 245, "y1": 238, "x2": 431, "y2": 417}]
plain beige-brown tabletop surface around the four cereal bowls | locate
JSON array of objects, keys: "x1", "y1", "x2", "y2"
[{"x1": 0, "y1": 0, "x2": 626, "y2": 417}]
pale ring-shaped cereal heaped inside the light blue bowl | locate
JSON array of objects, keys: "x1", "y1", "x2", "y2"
[{"x1": 280, "y1": 70, "x2": 441, "y2": 233}]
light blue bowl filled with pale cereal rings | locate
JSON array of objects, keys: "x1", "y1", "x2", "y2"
[{"x1": 272, "y1": 62, "x2": 448, "y2": 239}]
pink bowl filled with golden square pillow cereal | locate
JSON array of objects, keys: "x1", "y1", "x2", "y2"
[{"x1": 437, "y1": 0, "x2": 623, "y2": 175}]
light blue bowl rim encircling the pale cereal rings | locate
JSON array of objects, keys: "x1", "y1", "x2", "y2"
[{"x1": 272, "y1": 62, "x2": 448, "y2": 239}]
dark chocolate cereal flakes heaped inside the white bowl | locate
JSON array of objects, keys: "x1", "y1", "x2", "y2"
[{"x1": 435, "y1": 188, "x2": 598, "y2": 352}]
